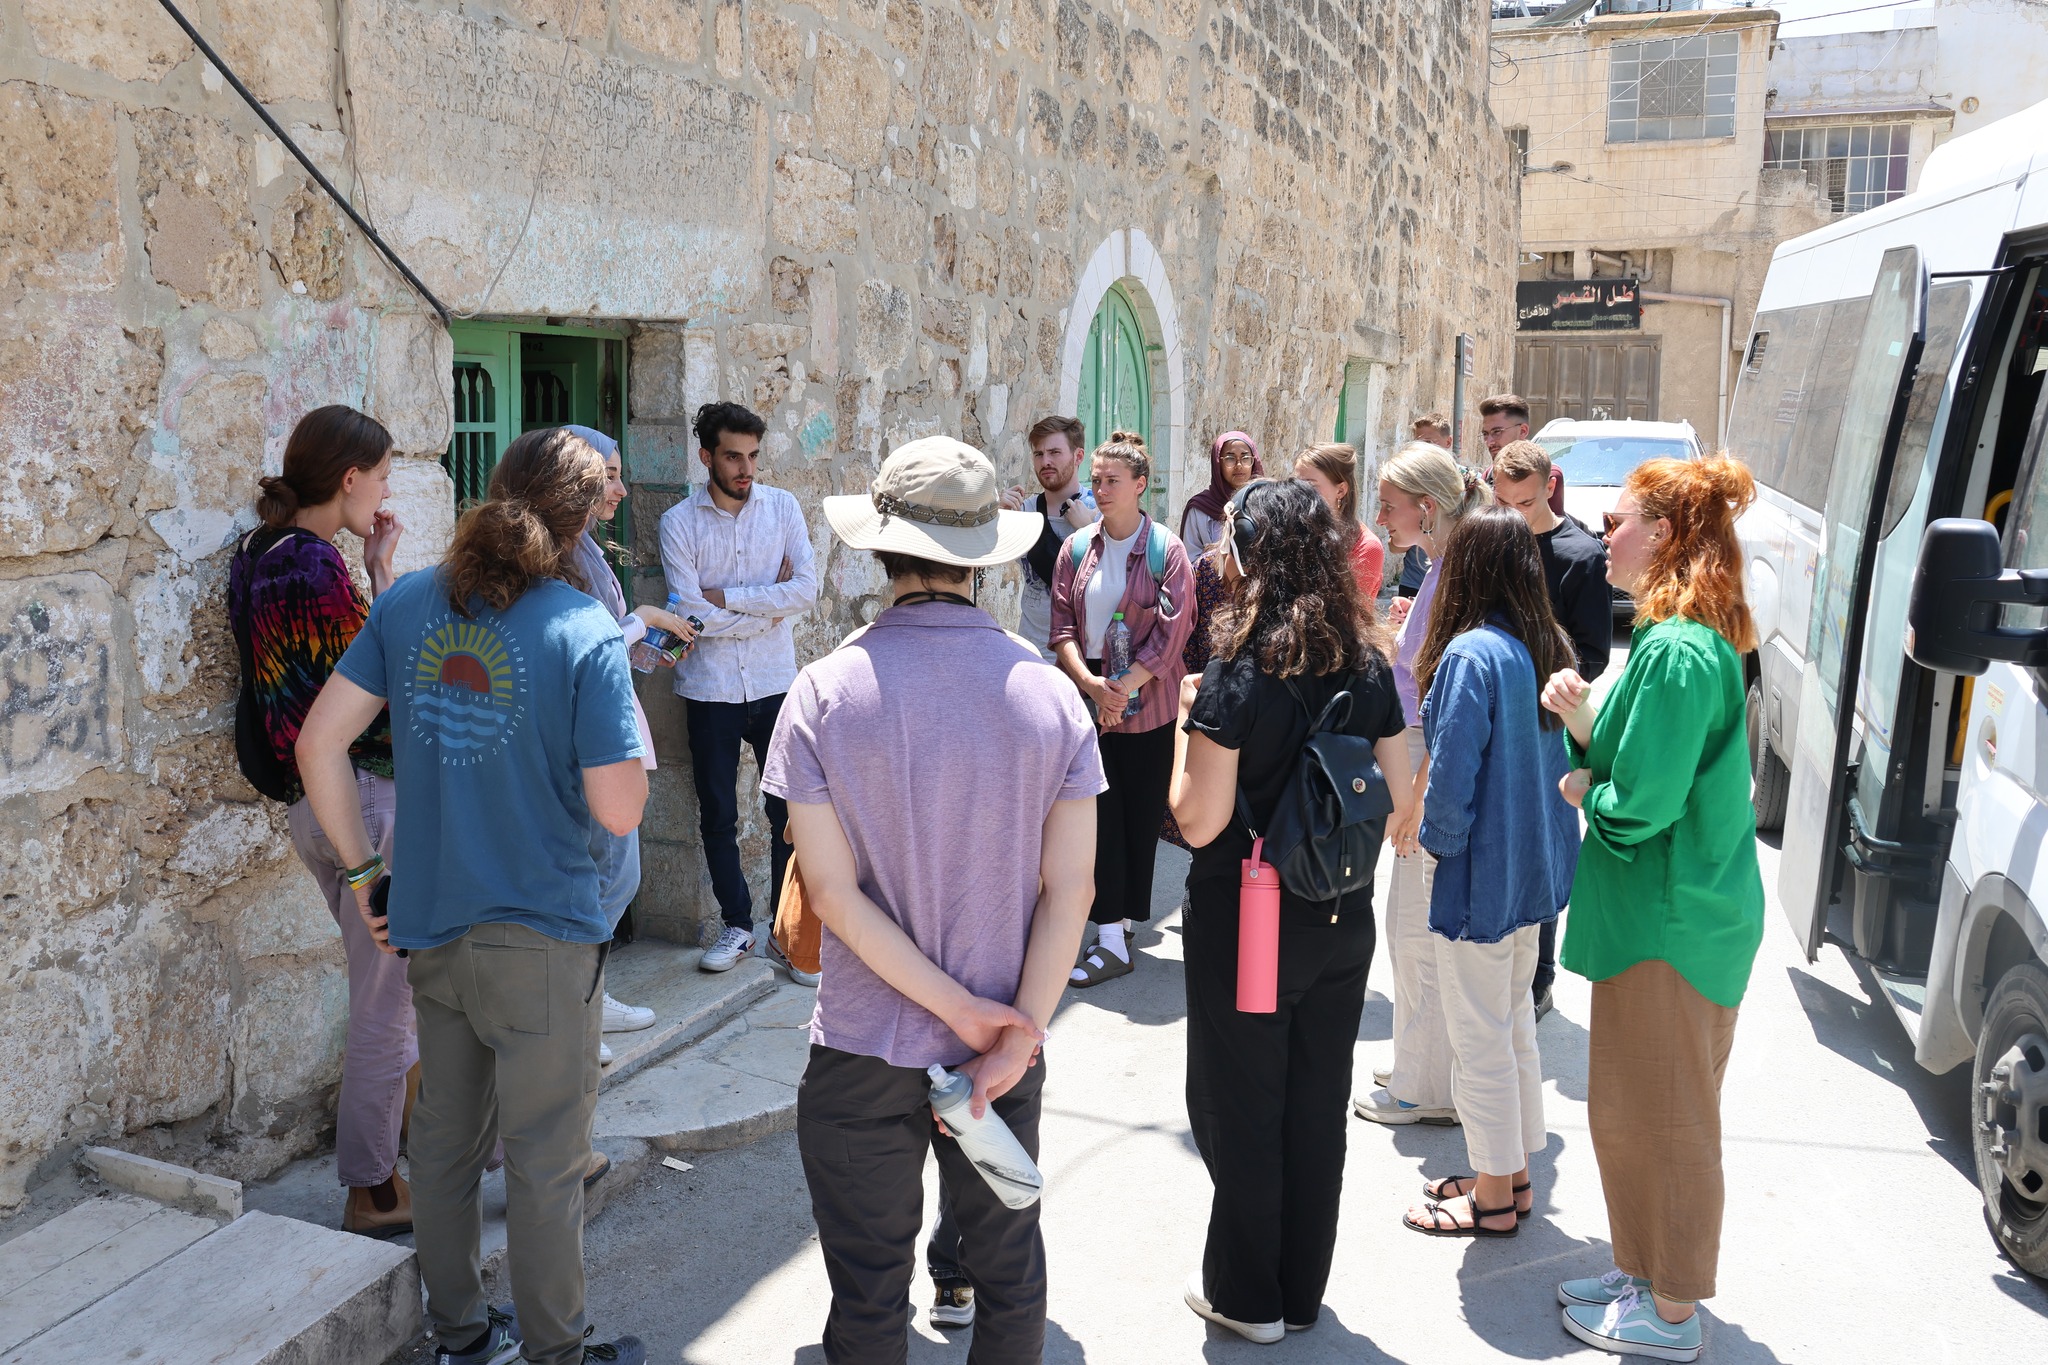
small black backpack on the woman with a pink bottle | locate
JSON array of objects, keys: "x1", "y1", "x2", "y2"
[{"x1": 1237, "y1": 679, "x2": 1395, "y2": 905}]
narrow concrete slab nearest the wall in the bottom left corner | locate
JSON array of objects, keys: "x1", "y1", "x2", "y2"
[{"x1": 0, "y1": 1195, "x2": 219, "y2": 1351}]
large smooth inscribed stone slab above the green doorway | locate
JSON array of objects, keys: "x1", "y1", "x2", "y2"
[{"x1": 348, "y1": 0, "x2": 770, "y2": 319}]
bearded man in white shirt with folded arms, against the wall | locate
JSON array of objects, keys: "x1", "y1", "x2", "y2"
[{"x1": 662, "y1": 403, "x2": 817, "y2": 972}]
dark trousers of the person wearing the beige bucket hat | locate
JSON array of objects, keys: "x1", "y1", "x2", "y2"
[{"x1": 797, "y1": 1044, "x2": 1047, "y2": 1365}]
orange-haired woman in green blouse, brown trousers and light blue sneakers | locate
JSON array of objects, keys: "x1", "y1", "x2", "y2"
[{"x1": 1544, "y1": 456, "x2": 1763, "y2": 1361}]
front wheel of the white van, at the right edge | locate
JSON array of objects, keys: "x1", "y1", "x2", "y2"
[{"x1": 1972, "y1": 962, "x2": 2048, "y2": 1275}]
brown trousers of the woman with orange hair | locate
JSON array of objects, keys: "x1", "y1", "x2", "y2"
[{"x1": 1587, "y1": 962, "x2": 1735, "y2": 1302}]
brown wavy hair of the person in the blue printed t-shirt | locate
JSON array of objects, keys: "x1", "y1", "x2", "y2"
[{"x1": 440, "y1": 426, "x2": 604, "y2": 616}]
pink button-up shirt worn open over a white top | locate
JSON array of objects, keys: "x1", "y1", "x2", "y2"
[{"x1": 1049, "y1": 518, "x2": 1194, "y2": 735}]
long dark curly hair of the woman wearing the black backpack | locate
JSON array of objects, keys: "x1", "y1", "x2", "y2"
[{"x1": 1210, "y1": 479, "x2": 1393, "y2": 677}]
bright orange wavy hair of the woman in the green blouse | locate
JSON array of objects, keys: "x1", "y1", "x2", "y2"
[{"x1": 1622, "y1": 454, "x2": 1757, "y2": 655}]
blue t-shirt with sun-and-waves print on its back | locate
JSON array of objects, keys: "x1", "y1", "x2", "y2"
[{"x1": 336, "y1": 569, "x2": 641, "y2": 948}]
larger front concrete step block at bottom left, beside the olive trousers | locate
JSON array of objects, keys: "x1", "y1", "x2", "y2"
[{"x1": 0, "y1": 1212, "x2": 420, "y2": 1365}]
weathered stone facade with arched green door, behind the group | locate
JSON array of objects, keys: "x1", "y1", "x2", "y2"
[{"x1": 0, "y1": 0, "x2": 1518, "y2": 1207}]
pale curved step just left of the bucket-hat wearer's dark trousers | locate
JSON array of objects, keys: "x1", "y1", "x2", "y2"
[{"x1": 596, "y1": 982, "x2": 817, "y2": 1152}]
